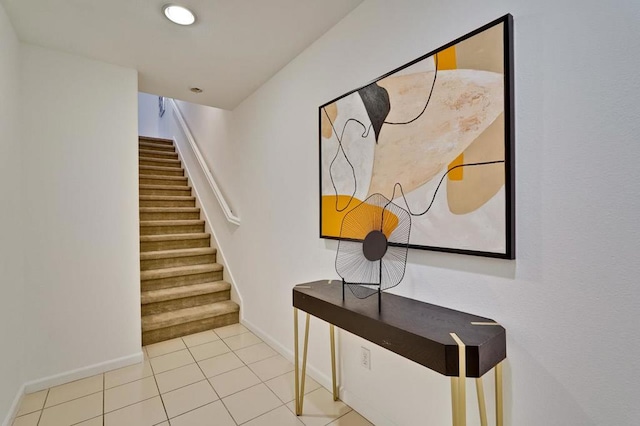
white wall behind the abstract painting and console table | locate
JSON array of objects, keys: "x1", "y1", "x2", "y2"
[{"x1": 171, "y1": 0, "x2": 640, "y2": 426}]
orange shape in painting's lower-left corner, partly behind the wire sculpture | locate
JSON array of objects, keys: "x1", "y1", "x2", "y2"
[{"x1": 322, "y1": 195, "x2": 398, "y2": 240}]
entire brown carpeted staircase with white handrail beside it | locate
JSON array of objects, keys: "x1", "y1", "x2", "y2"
[{"x1": 139, "y1": 137, "x2": 240, "y2": 345}]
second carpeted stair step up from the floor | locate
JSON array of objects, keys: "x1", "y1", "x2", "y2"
[{"x1": 141, "y1": 281, "x2": 231, "y2": 316}]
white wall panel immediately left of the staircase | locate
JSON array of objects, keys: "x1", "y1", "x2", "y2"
[{"x1": 21, "y1": 44, "x2": 141, "y2": 387}]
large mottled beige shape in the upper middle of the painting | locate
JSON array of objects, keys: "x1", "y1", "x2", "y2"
[{"x1": 369, "y1": 70, "x2": 504, "y2": 198}]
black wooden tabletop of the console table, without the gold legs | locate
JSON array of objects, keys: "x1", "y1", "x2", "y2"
[{"x1": 293, "y1": 280, "x2": 506, "y2": 377}]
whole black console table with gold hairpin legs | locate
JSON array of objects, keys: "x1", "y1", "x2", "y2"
[{"x1": 293, "y1": 280, "x2": 507, "y2": 426}]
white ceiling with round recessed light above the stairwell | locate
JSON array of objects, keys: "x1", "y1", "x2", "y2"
[{"x1": 0, "y1": 0, "x2": 363, "y2": 109}]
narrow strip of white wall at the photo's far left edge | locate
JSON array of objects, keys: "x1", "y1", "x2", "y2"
[{"x1": 0, "y1": 4, "x2": 24, "y2": 423}]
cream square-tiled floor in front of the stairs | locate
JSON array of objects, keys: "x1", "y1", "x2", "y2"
[{"x1": 13, "y1": 324, "x2": 371, "y2": 426}]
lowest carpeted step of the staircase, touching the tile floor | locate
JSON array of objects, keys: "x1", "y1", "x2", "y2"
[{"x1": 142, "y1": 300, "x2": 240, "y2": 345}]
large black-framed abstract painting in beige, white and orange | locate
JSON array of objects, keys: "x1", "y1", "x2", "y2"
[{"x1": 319, "y1": 15, "x2": 515, "y2": 259}]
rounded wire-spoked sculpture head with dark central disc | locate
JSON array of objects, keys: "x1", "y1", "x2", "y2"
[{"x1": 336, "y1": 194, "x2": 411, "y2": 298}]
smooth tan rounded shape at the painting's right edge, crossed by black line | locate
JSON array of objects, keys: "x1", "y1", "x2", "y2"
[{"x1": 447, "y1": 114, "x2": 505, "y2": 214}]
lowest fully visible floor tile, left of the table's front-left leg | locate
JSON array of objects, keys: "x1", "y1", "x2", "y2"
[{"x1": 222, "y1": 383, "x2": 282, "y2": 424}]
